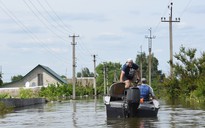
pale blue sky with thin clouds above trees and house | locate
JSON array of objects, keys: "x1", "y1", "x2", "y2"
[{"x1": 0, "y1": 0, "x2": 205, "y2": 82}]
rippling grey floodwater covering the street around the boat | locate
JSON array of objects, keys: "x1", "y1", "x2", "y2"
[{"x1": 0, "y1": 98, "x2": 205, "y2": 128}]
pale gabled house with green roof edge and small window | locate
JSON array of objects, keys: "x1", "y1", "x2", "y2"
[{"x1": 4, "y1": 64, "x2": 68, "y2": 88}]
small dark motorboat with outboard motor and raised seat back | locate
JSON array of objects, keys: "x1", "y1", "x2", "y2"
[{"x1": 104, "y1": 82, "x2": 160, "y2": 118}]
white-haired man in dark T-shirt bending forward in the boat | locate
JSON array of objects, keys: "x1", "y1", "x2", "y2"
[{"x1": 120, "y1": 59, "x2": 140, "y2": 88}]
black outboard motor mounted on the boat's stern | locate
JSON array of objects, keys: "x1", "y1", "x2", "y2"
[{"x1": 126, "y1": 87, "x2": 140, "y2": 117}]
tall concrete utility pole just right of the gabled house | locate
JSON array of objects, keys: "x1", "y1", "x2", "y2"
[{"x1": 69, "y1": 34, "x2": 79, "y2": 100}]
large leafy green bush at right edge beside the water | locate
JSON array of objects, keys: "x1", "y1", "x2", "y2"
[{"x1": 164, "y1": 46, "x2": 205, "y2": 101}]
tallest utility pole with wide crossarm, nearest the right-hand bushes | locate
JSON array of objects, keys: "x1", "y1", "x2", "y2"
[{"x1": 161, "y1": 3, "x2": 180, "y2": 77}]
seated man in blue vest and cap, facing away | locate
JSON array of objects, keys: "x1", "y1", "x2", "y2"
[{"x1": 138, "y1": 78, "x2": 155, "y2": 101}]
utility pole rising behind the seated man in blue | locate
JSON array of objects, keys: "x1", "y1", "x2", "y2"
[{"x1": 145, "y1": 28, "x2": 155, "y2": 86}]
